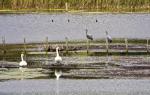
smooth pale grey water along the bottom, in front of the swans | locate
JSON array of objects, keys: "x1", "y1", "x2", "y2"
[{"x1": 0, "y1": 79, "x2": 150, "y2": 95}]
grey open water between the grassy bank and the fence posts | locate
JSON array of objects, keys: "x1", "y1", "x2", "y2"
[{"x1": 0, "y1": 14, "x2": 150, "y2": 43}]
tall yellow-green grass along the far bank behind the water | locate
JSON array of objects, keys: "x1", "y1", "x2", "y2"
[{"x1": 0, "y1": 0, "x2": 150, "y2": 12}]
